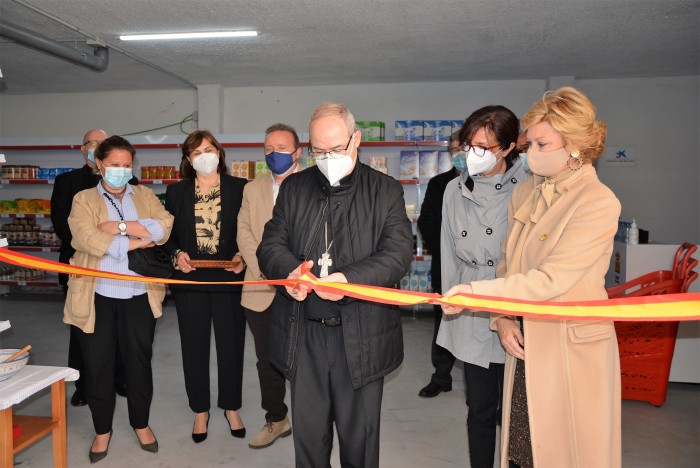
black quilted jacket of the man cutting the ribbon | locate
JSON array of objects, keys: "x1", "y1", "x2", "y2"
[{"x1": 257, "y1": 161, "x2": 413, "y2": 389}]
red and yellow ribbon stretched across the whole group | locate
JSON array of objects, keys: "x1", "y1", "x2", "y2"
[{"x1": 0, "y1": 248, "x2": 700, "y2": 321}]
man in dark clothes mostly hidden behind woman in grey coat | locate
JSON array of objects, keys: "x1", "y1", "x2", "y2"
[{"x1": 418, "y1": 131, "x2": 467, "y2": 398}]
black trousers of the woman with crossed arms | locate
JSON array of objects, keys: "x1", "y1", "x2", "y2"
[{"x1": 78, "y1": 294, "x2": 156, "y2": 434}]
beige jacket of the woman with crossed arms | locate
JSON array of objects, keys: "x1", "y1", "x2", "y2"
[{"x1": 63, "y1": 185, "x2": 173, "y2": 333}]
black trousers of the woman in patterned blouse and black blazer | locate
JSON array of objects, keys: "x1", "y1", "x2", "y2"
[{"x1": 174, "y1": 290, "x2": 245, "y2": 413}]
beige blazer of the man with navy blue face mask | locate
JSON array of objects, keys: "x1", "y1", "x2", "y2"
[{"x1": 236, "y1": 175, "x2": 276, "y2": 312}]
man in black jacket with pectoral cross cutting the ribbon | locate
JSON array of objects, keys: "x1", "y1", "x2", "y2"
[{"x1": 257, "y1": 104, "x2": 413, "y2": 467}]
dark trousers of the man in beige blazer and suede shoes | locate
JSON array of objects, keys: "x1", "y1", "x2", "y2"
[{"x1": 245, "y1": 308, "x2": 289, "y2": 422}]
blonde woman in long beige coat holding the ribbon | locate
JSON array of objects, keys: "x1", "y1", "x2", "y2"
[{"x1": 443, "y1": 87, "x2": 621, "y2": 468}]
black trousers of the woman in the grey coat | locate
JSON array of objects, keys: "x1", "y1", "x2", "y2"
[{"x1": 464, "y1": 362, "x2": 504, "y2": 468}]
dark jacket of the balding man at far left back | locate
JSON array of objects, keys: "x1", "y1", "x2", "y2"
[{"x1": 51, "y1": 164, "x2": 139, "y2": 285}]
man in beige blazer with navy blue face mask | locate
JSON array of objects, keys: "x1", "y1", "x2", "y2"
[{"x1": 236, "y1": 123, "x2": 301, "y2": 449}]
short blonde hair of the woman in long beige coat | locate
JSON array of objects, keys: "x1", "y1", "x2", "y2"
[{"x1": 520, "y1": 86, "x2": 608, "y2": 163}]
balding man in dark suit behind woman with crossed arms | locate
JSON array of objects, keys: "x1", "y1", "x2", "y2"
[{"x1": 51, "y1": 128, "x2": 138, "y2": 406}]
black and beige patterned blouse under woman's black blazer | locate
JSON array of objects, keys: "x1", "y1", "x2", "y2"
[{"x1": 194, "y1": 177, "x2": 221, "y2": 255}]
